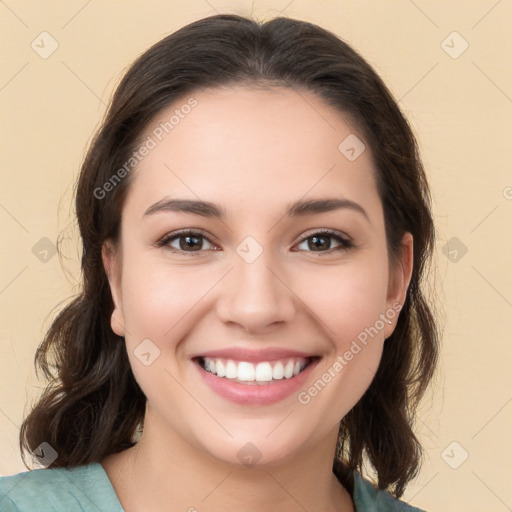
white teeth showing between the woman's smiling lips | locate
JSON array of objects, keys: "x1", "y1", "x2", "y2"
[{"x1": 195, "y1": 356, "x2": 320, "y2": 386}]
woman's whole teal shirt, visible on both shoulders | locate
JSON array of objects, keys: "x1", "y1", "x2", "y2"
[{"x1": 0, "y1": 462, "x2": 425, "y2": 512}]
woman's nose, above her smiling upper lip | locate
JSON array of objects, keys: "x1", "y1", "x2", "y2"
[{"x1": 217, "y1": 247, "x2": 298, "y2": 333}]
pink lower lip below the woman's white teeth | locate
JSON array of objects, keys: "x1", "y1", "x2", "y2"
[{"x1": 194, "y1": 359, "x2": 318, "y2": 405}]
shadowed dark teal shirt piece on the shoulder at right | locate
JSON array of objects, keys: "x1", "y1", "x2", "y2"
[{"x1": 354, "y1": 472, "x2": 426, "y2": 512}]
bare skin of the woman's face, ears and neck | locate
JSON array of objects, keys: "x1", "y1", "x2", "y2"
[{"x1": 102, "y1": 86, "x2": 413, "y2": 512}]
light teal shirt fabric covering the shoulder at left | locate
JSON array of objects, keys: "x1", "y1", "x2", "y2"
[{"x1": 0, "y1": 463, "x2": 123, "y2": 512}]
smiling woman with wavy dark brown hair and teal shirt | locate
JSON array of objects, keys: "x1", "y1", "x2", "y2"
[{"x1": 0, "y1": 15, "x2": 438, "y2": 512}]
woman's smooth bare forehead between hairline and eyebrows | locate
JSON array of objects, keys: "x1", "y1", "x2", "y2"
[{"x1": 126, "y1": 86, "x2": 376, "y2": 220}]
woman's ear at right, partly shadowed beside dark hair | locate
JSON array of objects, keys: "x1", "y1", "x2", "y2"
[{"x1": 384, "y1": 232, "x2": 414, "y2": 338}]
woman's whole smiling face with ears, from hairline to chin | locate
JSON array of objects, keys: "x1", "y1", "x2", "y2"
[{"x1": 104, "y1": 87, "x2": 412, "y2": 464}]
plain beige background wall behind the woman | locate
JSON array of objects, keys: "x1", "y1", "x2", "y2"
[{"x1": 0, "y1": 0, "x2": 512, "y2": 512}]
